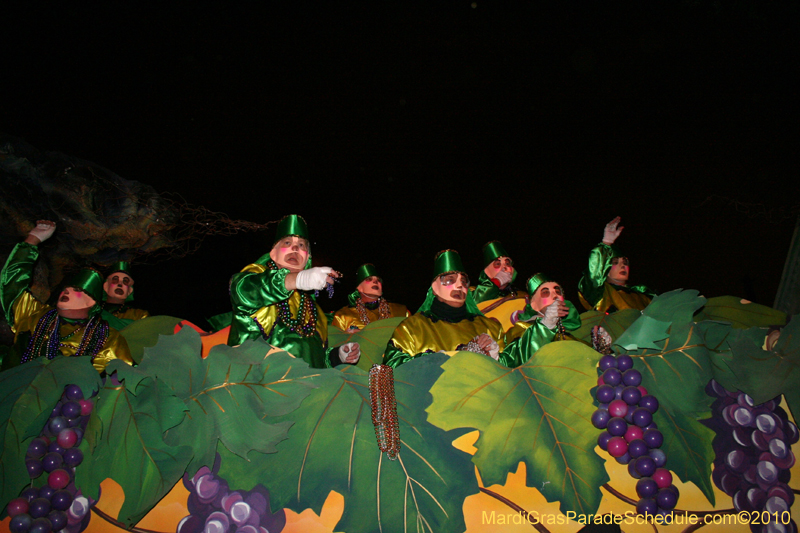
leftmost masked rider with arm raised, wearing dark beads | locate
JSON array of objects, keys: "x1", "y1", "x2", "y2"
[{"x1": 0, "y1": 220, "x2": 133, "y2": 372}]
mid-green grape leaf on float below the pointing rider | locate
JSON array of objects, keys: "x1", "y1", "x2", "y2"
[{"x1": 138, "y1": 328, "x2": 318, "y2": 472}]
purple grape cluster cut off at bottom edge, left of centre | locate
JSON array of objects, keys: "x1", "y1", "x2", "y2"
[{"x1": 177, "y1": 456, "x2": 286, "y2": 533}]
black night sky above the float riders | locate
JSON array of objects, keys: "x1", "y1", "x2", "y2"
[{"x1": 0, "y1": 0, "x2": 800, "y2": 326}]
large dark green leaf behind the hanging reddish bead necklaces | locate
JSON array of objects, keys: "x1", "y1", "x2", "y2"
[{"x1": 220, "y1": 354, "x2": 478, "y2": 533}]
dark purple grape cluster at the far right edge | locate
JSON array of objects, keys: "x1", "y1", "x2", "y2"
[{"x1": 705, "y1": 379, "x2": 800, "y2": 533}]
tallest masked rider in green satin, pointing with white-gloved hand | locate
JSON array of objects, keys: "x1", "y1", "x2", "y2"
[{"x1": 228, "y1": 215, "x2": 361, "y2": 368}]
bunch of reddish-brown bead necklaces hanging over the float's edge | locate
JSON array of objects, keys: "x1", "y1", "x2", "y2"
[{"x1": 369, "y1": 365, "x2": 400, "y2": 460}]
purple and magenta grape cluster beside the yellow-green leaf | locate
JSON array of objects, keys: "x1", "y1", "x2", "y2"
[{"x1": 592, "y1": 354, "x2": 679, "y2": 520}]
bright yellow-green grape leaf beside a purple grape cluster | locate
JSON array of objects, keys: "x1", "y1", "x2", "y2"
[{"x1": 428, "y1": 341, "x2": 608, "y2": 514}]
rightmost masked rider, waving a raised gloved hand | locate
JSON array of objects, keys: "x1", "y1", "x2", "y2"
[{"x1": 578, "y1": 217, "x2": 655, "y2": 313}]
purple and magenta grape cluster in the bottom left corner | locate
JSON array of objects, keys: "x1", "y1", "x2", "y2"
[{"x1": 7, "y1": 385, "x2": 94, "y2": 533}]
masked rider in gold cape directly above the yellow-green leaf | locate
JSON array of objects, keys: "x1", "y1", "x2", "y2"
[{"x1": 383, "y1": 250, "x2": 516, "y2": 368}]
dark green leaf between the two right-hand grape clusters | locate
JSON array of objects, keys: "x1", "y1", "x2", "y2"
[{"x1": 653, "y1": 406, "x2": 716, "y2": 505}]
